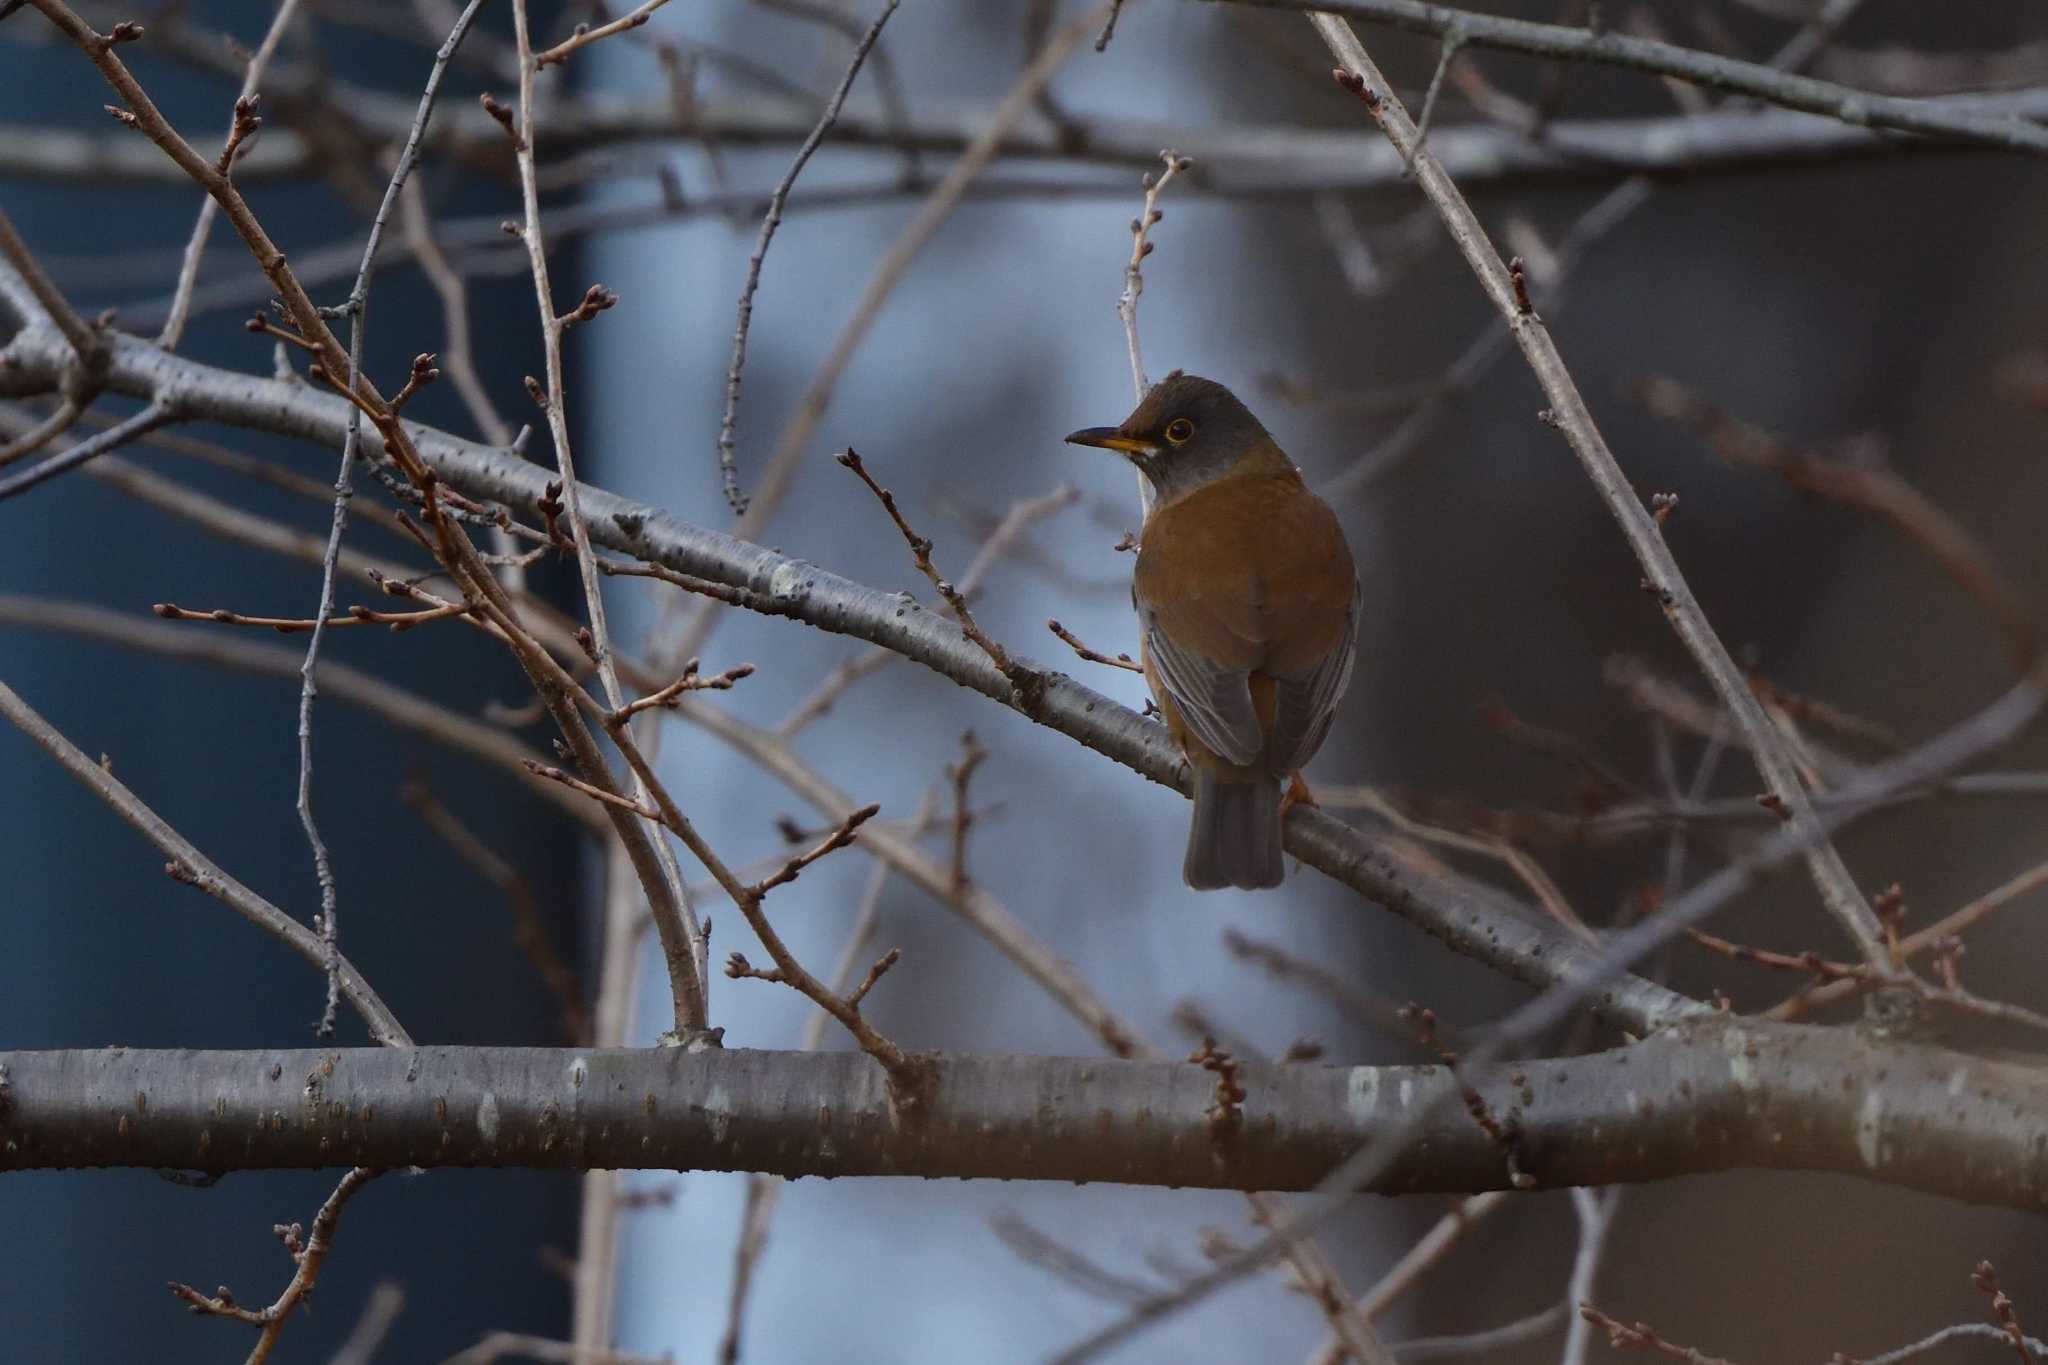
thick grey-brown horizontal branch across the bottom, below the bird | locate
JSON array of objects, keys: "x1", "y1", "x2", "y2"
[{"x1": 12, "y1": 1017, "x2": 2048, "y2": 1212}]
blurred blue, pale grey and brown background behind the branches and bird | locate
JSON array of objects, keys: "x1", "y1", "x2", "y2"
[{"x1": 0, "y1": 0, "x2": 2048, "y2": 1361}]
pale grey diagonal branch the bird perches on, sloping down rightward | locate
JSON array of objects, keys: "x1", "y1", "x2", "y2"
[{"x1": 0, "y1": 313, "x2": 1706, "y2": 1033}]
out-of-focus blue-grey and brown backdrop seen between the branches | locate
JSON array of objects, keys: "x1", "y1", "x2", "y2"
[{"x1": 12, "y1": 0, "x2": 2048, "y2": 1361}]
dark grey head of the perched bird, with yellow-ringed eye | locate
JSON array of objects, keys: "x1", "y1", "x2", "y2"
[{"x1": 1067, "y1": 370, "x2": 1292, "y2": 501}]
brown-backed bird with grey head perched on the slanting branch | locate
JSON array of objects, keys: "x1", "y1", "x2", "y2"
[{"x1": 1067, "y1": 370, "x2": 1360, "y2": 890}]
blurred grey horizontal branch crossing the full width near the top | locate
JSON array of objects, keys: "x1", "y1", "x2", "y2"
[{"x1": 0, "y1": 90, "x2": 2048, "y2": 194}]
